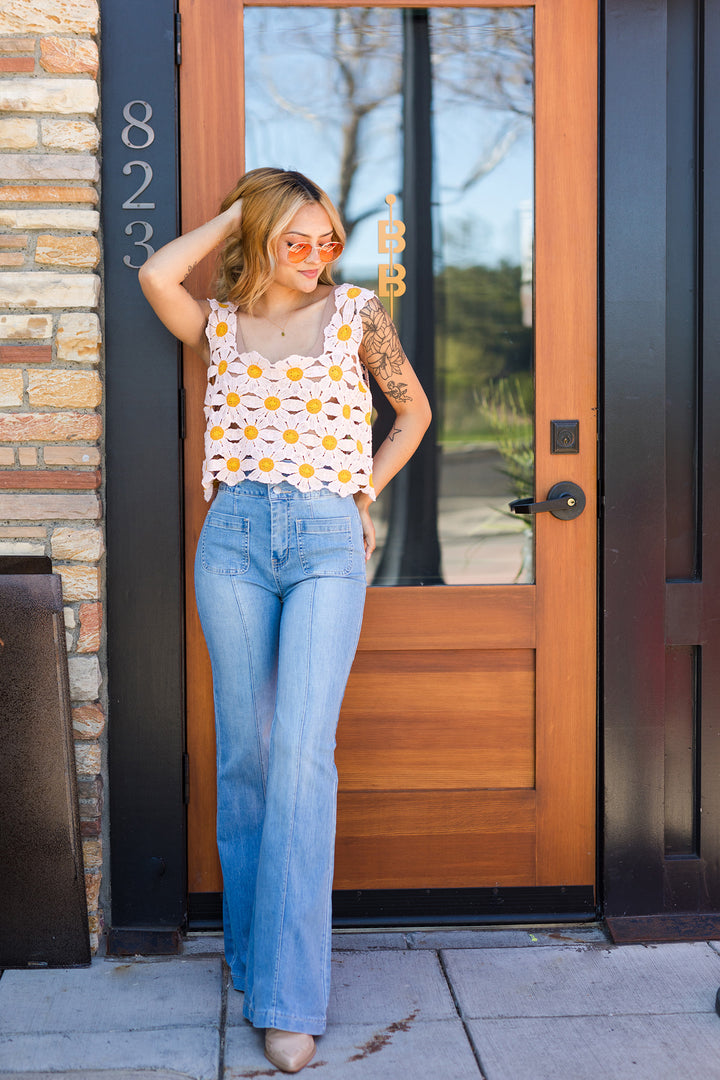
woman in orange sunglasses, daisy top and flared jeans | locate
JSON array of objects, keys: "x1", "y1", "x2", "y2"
[{"x1": 139, "y1": 168, "x2": 430, "y2": 1072}]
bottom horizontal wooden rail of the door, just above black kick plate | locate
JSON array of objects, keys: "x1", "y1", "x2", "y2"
[{"x1": 335, "y1": 791, "x2": 535, "y2": 889}]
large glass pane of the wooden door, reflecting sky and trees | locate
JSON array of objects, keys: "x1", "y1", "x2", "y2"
[{"x1": 245, "y1": 8, "x2": 533, "y2": 585}]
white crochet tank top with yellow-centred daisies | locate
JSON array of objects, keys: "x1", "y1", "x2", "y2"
[{"x1": 203, "y1": 284, "x2": 375, "y2": 501}]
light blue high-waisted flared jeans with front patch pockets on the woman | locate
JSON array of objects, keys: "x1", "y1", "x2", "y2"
[{"x1": 195, "y1": 481, "x2": 366, "y2": 1035}]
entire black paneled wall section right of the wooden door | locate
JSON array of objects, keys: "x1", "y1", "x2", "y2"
[{"x1": 603, "y1": 0, "x2": 720, "y2": 940}]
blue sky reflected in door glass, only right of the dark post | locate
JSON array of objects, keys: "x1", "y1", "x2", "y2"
[{"x1": 430, "y1": 9, "x2": 533, "y2": 266}]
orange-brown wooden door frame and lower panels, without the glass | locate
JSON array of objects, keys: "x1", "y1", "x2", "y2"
[{"x1": 180, "y1": 0, "x2": 597, "y2": 911}]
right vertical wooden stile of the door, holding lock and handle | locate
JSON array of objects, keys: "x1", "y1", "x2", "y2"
[{"x1": 535, "y1": 0, "x2": 597, "y2": 885}]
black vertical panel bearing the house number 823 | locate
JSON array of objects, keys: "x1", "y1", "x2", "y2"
[{"x1": 101, "y1": 0, "x2": 186, "y2": 929}]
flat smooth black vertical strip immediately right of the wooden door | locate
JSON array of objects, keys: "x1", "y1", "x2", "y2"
[{"x1": 603, "y1": 0, "x2": 667, "y2": 914}]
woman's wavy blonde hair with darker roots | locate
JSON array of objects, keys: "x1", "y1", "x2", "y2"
[{"x1": 215, "y1": 168, "x2": 345, "y2": 312}]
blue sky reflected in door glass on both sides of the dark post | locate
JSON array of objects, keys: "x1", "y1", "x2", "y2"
[{"x1": 245, "y1": 8, "x2": 533, "y2": 278}]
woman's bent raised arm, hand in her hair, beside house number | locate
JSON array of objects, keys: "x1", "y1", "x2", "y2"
[{"x1": 138, "y1": 200, "x2": 241, "y2": 360}]
